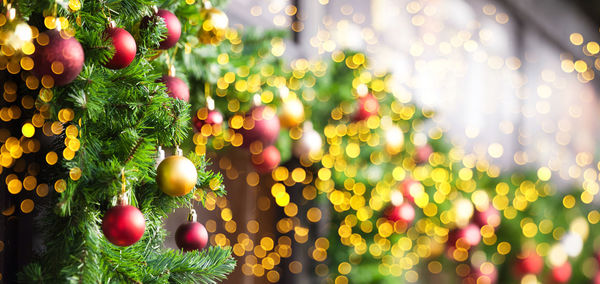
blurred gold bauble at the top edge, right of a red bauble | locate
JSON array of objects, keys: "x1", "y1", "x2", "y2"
[{"x1": 198, "y1": 1, "x2": 229, "y2": 44}]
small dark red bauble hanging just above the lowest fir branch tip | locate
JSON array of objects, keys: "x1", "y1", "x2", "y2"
[{"x1": 175, "y1": 209, "x2": 208, "y2": 251}]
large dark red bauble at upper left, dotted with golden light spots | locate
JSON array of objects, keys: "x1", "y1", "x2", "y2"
[{"x1": 33, "y1": 30, "x2": 85, "y2": 86}]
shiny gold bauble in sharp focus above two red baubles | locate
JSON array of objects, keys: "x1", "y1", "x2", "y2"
[{"x1": 156, "y1": 148, "x2": 198, "y2": 196}]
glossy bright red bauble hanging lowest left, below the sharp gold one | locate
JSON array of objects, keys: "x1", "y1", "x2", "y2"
[{"x1": 102, "y1": 205, "x2": 146, "y2": 247}]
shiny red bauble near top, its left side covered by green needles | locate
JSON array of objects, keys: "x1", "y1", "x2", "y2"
[{"x1": 104, "y1": 27, "x2": 137, "y2": 69}]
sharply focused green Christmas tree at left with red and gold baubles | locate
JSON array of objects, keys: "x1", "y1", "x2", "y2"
[{"x1": 0, "y1": 0, "x2": 235, "y2": 283}]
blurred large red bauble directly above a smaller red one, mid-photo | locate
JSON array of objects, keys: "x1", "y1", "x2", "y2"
[{"x1": 239, "y1": 106, "x2": 279, "y2": 147}]
